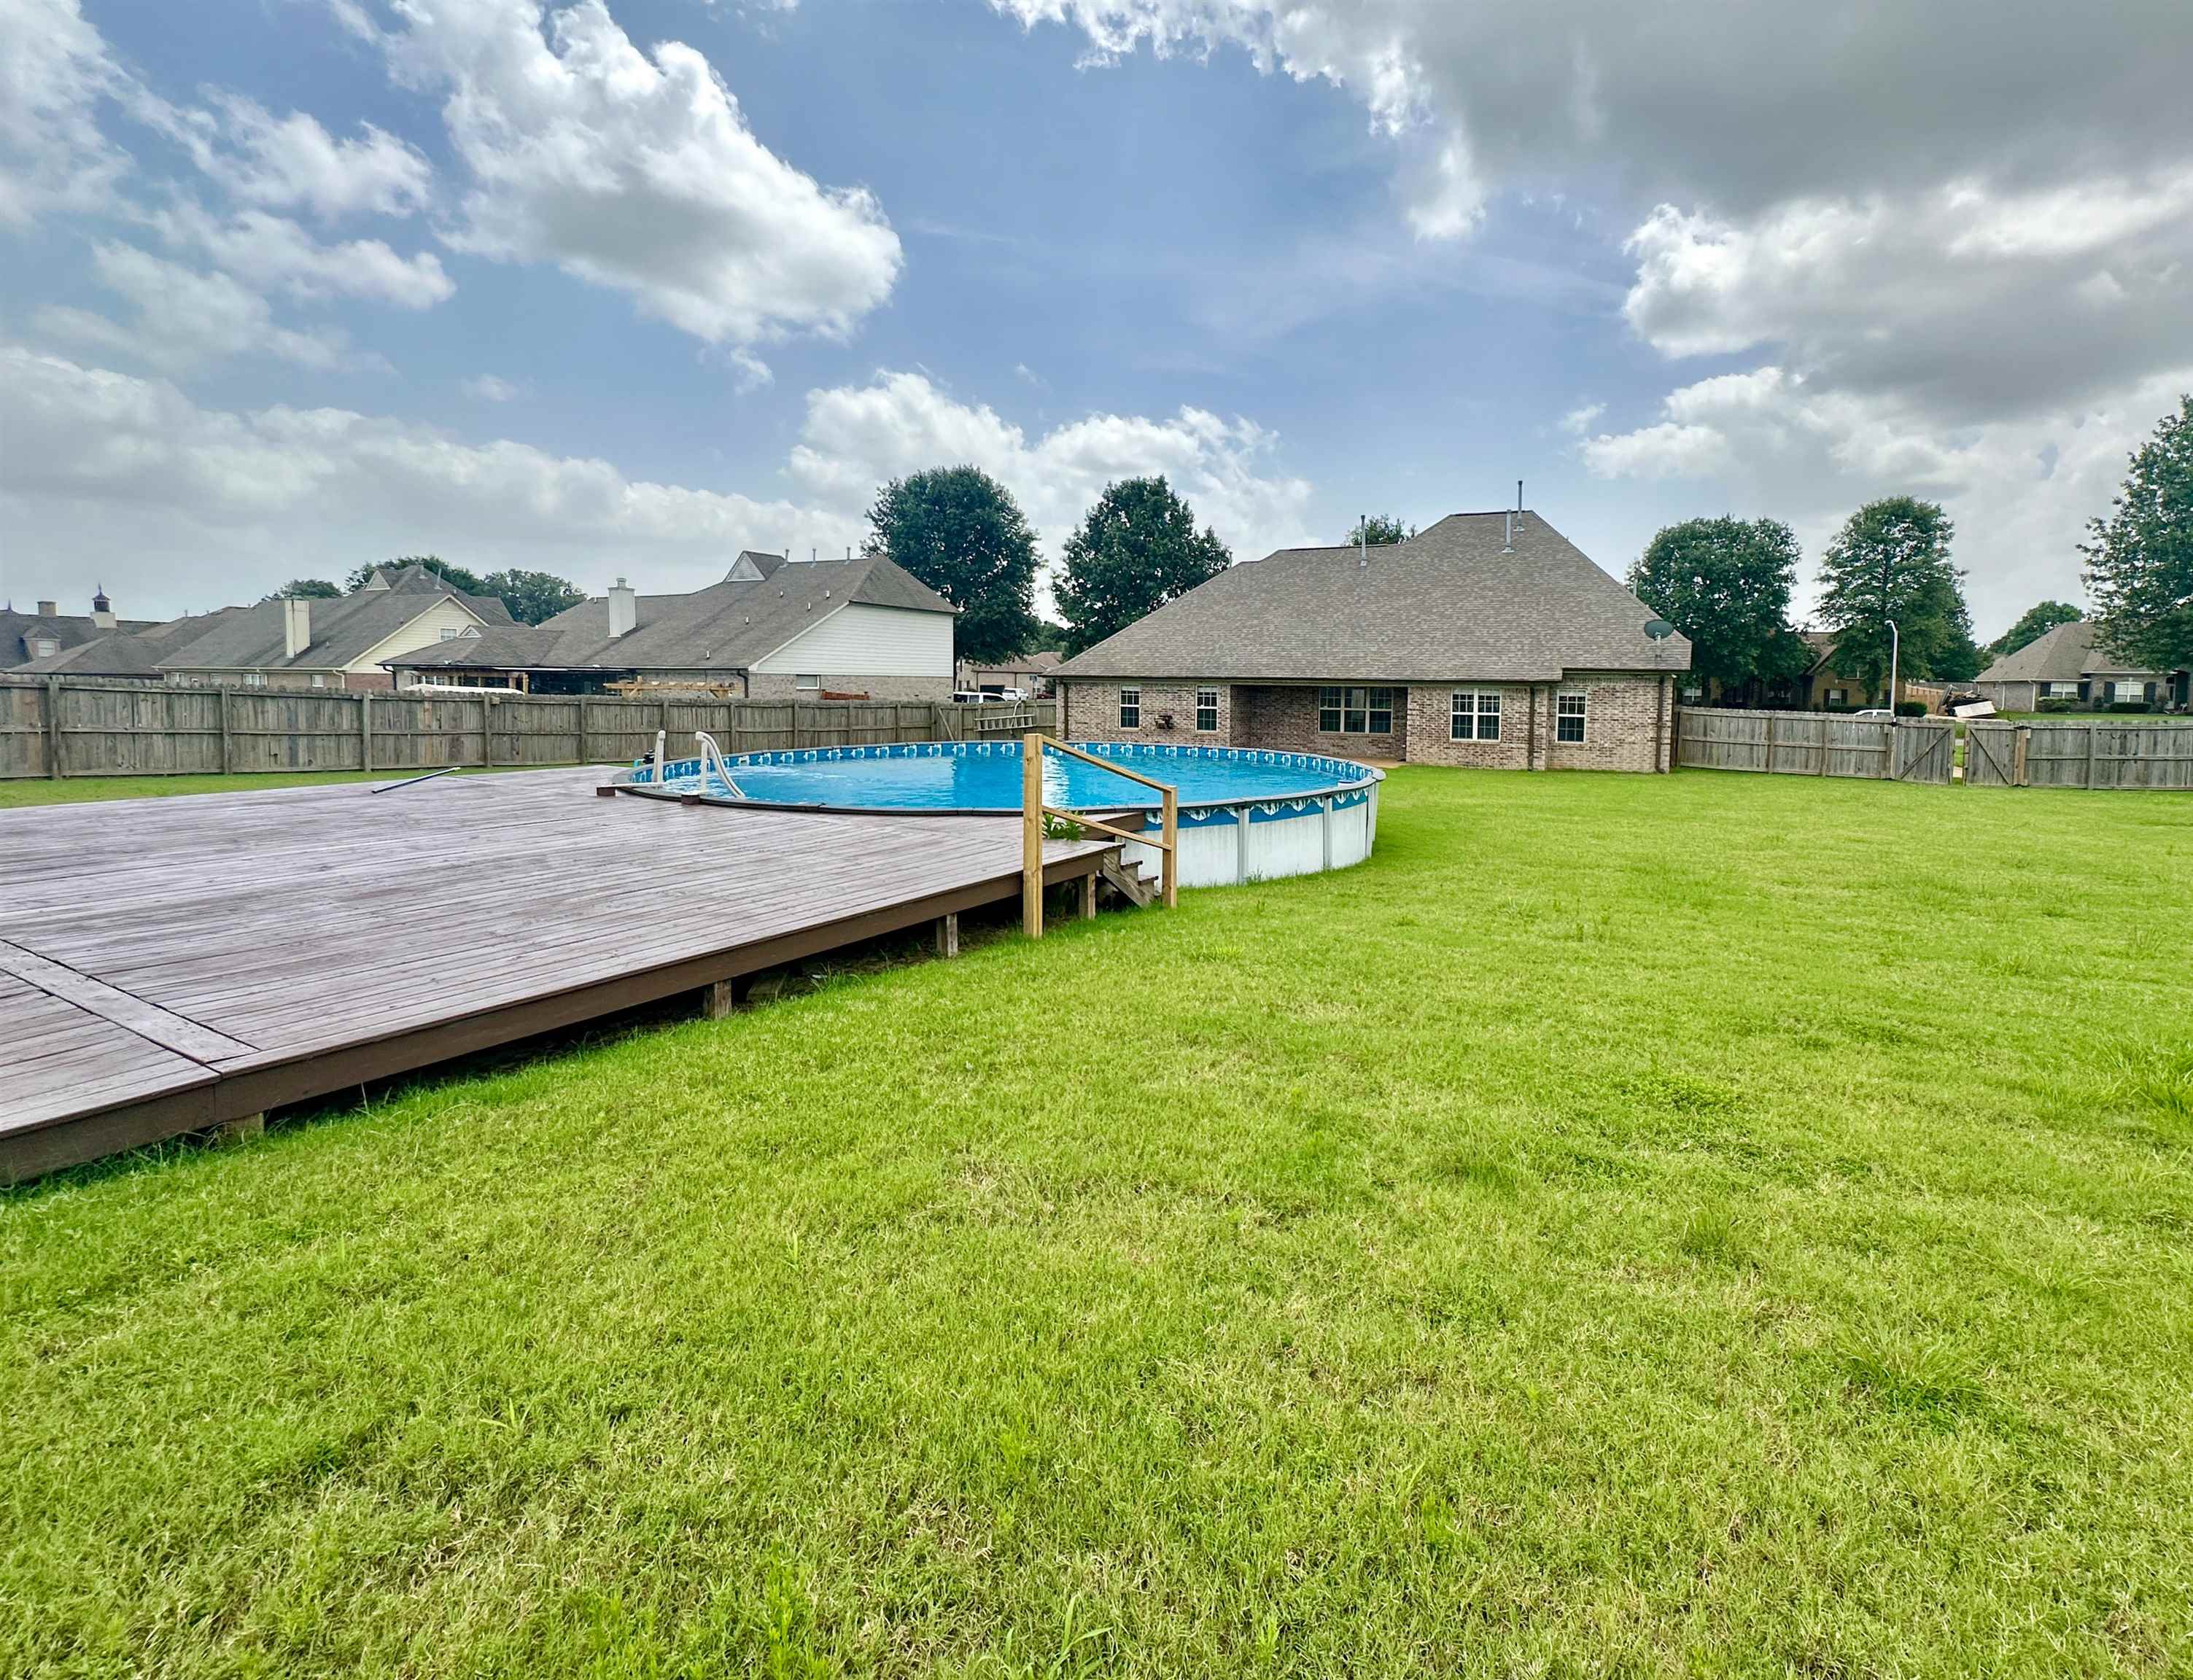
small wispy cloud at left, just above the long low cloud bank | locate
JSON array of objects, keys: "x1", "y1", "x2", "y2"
[{"x1": 36, "y1": 241, "x2": 353, "y2": 373}]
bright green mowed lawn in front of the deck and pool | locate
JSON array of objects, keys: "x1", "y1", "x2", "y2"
[{"x1": 0, "y1": 770, "x2": 2193, "y2": 1676}]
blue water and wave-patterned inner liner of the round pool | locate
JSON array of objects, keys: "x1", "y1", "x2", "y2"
[{"x1": 632, "y1": 742, "x2": 1379, "y2": 812}]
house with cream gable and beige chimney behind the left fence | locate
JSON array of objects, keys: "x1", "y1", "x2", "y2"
[{"x1": 155, "y1": 566, "x2": 511, "y2": 688}]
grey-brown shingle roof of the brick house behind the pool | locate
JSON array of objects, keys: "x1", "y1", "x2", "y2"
[{"x1": 1052, "y1": 511, "x2": 1691, "y2": 682}]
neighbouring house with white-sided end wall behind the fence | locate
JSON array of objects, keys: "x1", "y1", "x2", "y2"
[{"x1": 384, "y1": 551, "x2": 954, "y2": 699}]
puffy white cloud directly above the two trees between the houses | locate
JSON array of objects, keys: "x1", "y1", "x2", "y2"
[{"x1": 792, "y1": 373, "x2": 1309, "y2": 559}]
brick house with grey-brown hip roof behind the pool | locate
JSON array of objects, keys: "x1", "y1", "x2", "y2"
[{"x1": 1055, "y1": 511, "x2": 1691, "y2": 770}]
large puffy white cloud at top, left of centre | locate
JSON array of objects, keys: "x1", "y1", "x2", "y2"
[{"x1": 353, "y1": 0, "x2": 901, "y2": 351}]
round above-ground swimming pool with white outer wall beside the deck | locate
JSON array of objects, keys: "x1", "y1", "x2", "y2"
[{"x1": 616, "y1": 742, "x2": 1383, "y2": 886}]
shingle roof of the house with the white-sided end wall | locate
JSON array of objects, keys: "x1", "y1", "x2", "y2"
[{"x1": 386, "y1": 555, "x2": 952, "y2": 671}]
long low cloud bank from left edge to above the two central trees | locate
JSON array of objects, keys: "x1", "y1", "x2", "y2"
[{"x1": 0, "y1": 346, "x2": 1307, "y2": 614}]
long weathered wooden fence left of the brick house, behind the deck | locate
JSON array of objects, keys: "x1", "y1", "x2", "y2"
[{"x1": 0, "y1": 677, "x2": 1057, "y2": 781}]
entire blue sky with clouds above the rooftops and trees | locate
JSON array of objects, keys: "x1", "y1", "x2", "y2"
[{"x1": 0, "y1": 0, "x2": 2193, "y2": 631}]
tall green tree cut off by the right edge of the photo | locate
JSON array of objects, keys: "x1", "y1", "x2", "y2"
[{"x1": 2079, "y1": 394, "x2": 2193, "y2": 671}]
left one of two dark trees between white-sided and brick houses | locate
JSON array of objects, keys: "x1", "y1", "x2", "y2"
[{"x1": 862, "y1": 467, "x2": 1037, "y2": 664}]
